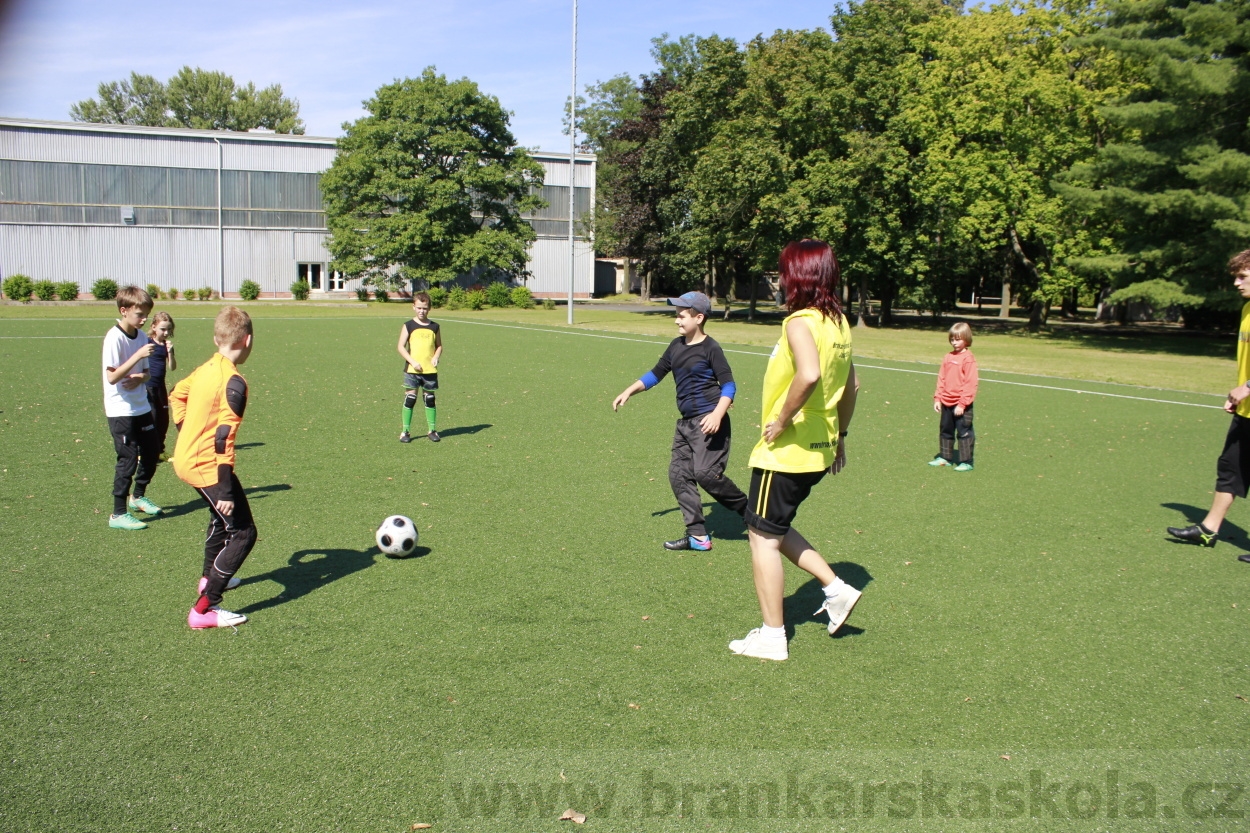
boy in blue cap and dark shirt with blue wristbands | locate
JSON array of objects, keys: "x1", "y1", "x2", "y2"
[{"x1": 613, "y1": 293, "x2": 746, "y2": 550}]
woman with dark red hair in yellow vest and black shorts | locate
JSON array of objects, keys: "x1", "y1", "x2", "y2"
[{"x1": 729, "y1": 240, "x2": 860, "y2": 659}]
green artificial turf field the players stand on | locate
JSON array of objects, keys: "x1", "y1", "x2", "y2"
[{"x1": 0, "y1": 304, "x2": 1250, "y2": 832}]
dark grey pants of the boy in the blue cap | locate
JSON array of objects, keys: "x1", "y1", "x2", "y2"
[{"x1": 669, "y1": 415, "x2": 746, "y2": 538}]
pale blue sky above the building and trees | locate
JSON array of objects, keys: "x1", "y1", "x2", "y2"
[{"x1": 0, "y1": 0, "x2": 834, "y2": 150}]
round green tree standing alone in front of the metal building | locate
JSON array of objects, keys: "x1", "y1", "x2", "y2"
[{"x1": 321, "y1": 68, "x2": 544, "y2": 286}]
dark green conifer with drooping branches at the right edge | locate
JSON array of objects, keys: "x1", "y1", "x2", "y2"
[{"x1": 1059, "y1": 0, "x2": 1250, "y2": 303}]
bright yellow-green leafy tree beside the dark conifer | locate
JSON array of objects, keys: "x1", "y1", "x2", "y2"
[{"x1": 900, "y1": 0, "x2": 1116, "y2": 326}]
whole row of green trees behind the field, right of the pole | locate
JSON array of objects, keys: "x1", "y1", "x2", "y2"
[{"x1": 578, "y1": 0, "x2": 1250, "y2": 325}]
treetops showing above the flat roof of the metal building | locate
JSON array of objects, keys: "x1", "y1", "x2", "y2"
[{"x1": 70, "y1": 66, "x2": 304, "y2": 134}]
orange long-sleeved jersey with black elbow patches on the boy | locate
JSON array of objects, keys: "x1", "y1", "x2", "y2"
[{"x1": 169, "y1": 353, "x2": 248, "y2": 489}]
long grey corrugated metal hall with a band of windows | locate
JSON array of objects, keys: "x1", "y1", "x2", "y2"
[{"x1": 0, "y1": 119, "x2": 595, "y2": 298}]
